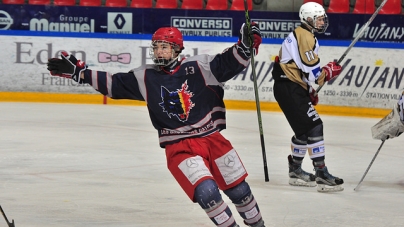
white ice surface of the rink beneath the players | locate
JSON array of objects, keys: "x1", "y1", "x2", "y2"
[{"x1": 0, "y1": 103, "x2": 404, "y2": 227}]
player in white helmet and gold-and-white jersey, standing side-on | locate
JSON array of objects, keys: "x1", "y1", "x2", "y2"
[{"x1": 272, "y1": 2, "x2": 344, "y2": 192}]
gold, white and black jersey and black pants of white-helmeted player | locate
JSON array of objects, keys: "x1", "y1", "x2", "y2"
[{"x1": 272, "y1": 27, "x2": 325, "y2": 136}]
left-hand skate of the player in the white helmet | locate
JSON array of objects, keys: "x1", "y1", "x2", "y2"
[{"x1": 288, "y1": 155, "x2": 316, "y2": 187}]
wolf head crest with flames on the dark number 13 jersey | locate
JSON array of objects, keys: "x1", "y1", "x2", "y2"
[{"x1": 159, "y1": 81, "x2": 195, "y2": 121}]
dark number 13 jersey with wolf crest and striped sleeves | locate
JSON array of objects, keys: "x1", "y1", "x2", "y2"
[{"x1": 84, "y1": 45, "x2": 249, "y2": 147}]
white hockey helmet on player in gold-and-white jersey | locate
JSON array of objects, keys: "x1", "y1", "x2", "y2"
[{"x1": 299, "y1": 2, "x2": 328, "y2": 33}]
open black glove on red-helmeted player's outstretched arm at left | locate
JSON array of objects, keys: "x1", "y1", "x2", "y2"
[{"x1": 48, "y1": 51, "x2": 87, "y2": 83}]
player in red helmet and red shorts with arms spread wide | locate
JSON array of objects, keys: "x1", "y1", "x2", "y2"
[{"x1": 48, "y1": 23, "x2": 264, "y2": 227}]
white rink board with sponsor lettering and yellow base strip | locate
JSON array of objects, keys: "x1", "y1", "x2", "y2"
[{"x1": 0, "y1": 31, "x2": 404, "y2": 116}]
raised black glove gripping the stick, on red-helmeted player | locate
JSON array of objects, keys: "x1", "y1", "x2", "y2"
[{"x1": 237, "y1": 22, "x2": 262, "y2": 58}]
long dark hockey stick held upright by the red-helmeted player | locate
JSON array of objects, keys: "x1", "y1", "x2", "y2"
[{"x1": 244, "y1": 0, "x2": 269, "y2": 182}]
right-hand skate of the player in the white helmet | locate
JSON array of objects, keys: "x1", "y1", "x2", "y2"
[{"x1": 314, "y1": 166, "x2": 344, "y2": 192}]
